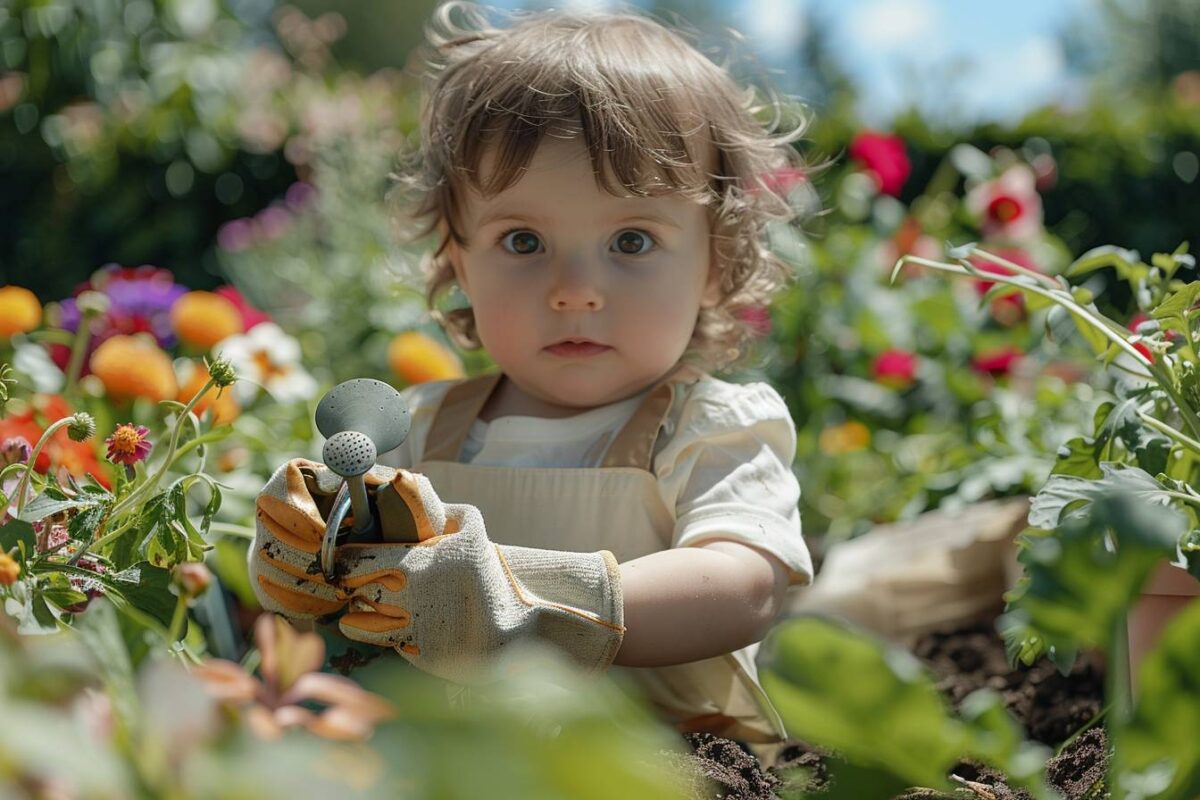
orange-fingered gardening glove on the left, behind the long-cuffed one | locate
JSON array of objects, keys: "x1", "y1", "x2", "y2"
[{"x1": 248, "y1": 458, "x2": 413, "y2": 619}]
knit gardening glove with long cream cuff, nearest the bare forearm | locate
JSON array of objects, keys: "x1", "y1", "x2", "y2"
[{"x1": 337, "y1": 470, "x2": 625, "y2": 684}]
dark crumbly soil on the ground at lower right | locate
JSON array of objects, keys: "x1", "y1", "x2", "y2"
[{"x1": 682, "y1": 621, "x2": 1109, "y2": 800}]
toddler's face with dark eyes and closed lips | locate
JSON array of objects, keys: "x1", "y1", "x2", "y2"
[{"x1": 449, "y1": 136, "x2": 719, "y2": 415}]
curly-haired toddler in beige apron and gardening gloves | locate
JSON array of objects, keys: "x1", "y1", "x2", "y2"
[{"x1": 251, "y1": 4, "x2": 812, "y2": 742}]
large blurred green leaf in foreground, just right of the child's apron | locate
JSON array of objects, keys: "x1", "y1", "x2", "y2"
[{"x1": 762, "y1": 616, "x2": 970, "y2": 789}]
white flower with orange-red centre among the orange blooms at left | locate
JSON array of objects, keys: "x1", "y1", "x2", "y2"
[{"x1": 212, "y1": 323, "x2": 317, "y2": 405}]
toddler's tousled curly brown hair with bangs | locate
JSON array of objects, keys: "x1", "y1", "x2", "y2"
[{"x1": 392, "y1": 2, "x2": 806, "y2": 368}]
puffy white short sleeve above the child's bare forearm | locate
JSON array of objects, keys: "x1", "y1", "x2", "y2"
[{"x1": 654, "y1": 377, "x2": 812, "y2": 584}]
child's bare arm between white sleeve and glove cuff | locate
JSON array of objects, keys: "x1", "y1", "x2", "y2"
[{"x1": 613, "y1": 541, "x2": 788, "y2": 667}]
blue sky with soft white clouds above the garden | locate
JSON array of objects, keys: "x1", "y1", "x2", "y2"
[{"x1": 496, "y1": 0, "x2": 1094, "y2": 125}]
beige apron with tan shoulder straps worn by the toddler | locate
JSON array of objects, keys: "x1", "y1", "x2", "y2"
[{"x1": 413, "y1": 367, "x2": 784, "y2": 742}]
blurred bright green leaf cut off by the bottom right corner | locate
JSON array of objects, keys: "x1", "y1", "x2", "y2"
[{"x1": 1114, "y1": 600, "x2": 1200, "y2": 799}]
